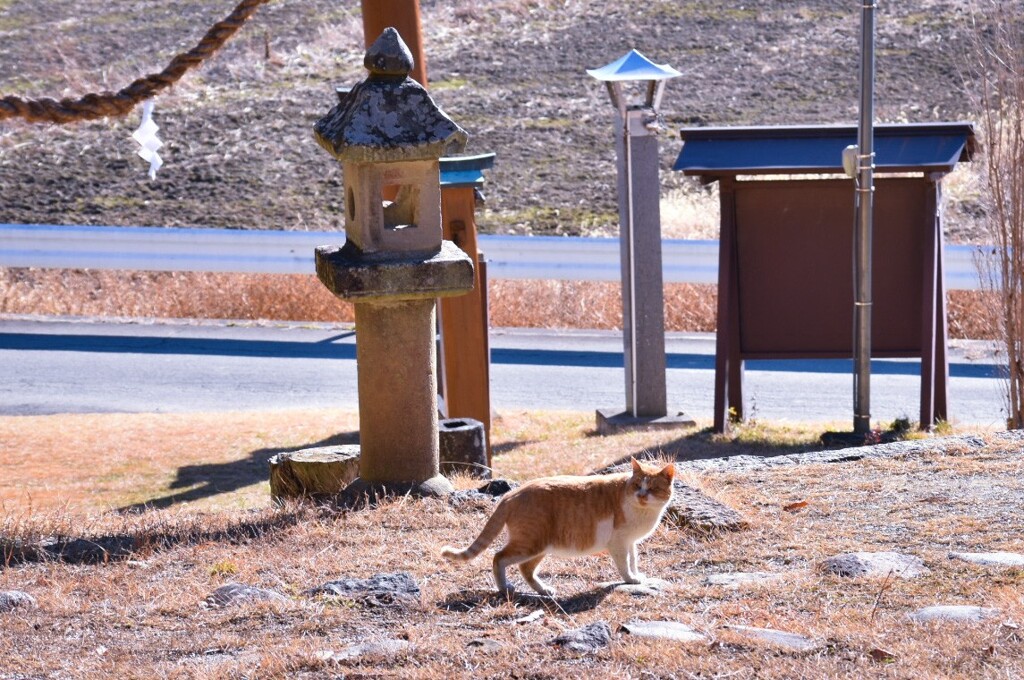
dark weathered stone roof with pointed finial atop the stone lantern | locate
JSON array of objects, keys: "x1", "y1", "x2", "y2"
[{"x1": 313, "y1": 28, "x2": 468, "y2": 163}]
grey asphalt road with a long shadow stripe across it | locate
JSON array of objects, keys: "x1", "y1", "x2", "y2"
[{"x1": 0, "y1": 317, "x2": 1005, "y2": 427}]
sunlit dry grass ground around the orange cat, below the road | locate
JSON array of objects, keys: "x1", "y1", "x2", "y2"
[{"x1": 0, "y1": 411, "x2": 1024, "y2": 680}]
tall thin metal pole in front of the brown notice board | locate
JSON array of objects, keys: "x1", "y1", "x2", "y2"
[{"x1": 853, "y1": 0, "x2": 877, "y2": 434}]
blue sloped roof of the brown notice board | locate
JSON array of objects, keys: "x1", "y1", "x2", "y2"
[{"x1": 674, "y1": 122, "x2": 977, "y2": 178}]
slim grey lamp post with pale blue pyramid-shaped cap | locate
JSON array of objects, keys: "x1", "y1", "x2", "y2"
[{"x1": 587, "y1": 49, "x2": 693, "y2": 432}]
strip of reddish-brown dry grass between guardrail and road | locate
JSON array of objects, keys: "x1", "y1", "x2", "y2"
[{"x1": 0, "y1": 268, "x2": 998, "y2": 340}]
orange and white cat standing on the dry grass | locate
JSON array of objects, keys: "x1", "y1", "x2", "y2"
[{"x1": 441, "y1": 460, "x2": 676, "y2": 596}]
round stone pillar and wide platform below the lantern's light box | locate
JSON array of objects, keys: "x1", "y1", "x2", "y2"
[{"x1": 316, "y1": 241, "x2": 473, "y2": 501}]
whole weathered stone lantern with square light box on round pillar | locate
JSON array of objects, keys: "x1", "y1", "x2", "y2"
[{"x1": 313, "y1": 28, "x2": 473, "y2": 497}]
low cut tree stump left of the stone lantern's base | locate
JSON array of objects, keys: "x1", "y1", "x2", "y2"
[{"x1": 269, "y1": 444, "x2": 359, "y2": 501}]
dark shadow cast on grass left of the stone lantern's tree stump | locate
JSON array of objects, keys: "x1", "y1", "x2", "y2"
[{"x1": 117, "y1": 432, "x2": 359, "y2": 513}]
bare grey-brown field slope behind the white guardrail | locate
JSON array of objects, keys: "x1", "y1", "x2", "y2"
[{"x1": 0, "y1": 0, "x2": 980, "y2": 241}]
